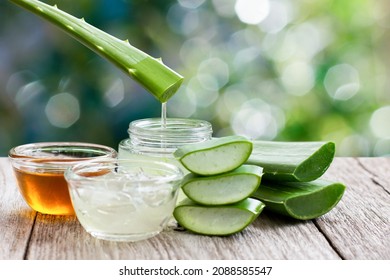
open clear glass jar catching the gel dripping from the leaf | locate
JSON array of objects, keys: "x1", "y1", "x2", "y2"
[{"x1": 118, "y1": 118, "x2": 213, "y2": 173}]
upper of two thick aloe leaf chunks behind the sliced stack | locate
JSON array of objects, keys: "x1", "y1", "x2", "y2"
[{"x1": 247, "y1": 140, "x2": 335, "y2": 182}]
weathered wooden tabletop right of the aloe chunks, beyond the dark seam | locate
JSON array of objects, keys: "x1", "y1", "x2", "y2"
[{"x1": 316, "y1": 158, "x2": 390, "y2": 259}]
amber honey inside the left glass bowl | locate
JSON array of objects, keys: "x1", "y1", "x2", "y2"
[{"x1": 14, "y1": 169, "x2": 74, "y2": 215}]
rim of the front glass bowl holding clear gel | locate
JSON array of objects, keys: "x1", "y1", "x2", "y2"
[{"x1": 65, "y1": 158, "x2": 183, "y2": 184}]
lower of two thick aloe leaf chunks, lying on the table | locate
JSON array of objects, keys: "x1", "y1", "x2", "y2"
[{"x1": 251, "y1": 179, "x2": 346, "y2": 220}]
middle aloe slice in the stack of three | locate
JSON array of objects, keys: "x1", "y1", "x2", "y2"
[{"x1": 182, "y1": 164, "x2": 263, "y2": 205}]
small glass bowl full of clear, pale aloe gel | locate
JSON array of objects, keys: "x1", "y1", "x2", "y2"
[{"x1": 65, "y1": 159, "x2": 183, "y2": 241}]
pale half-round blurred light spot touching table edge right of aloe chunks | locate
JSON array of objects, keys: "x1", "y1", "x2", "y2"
[{"x1": 338, "y1": 134, "x2": 370, "y2": 157}]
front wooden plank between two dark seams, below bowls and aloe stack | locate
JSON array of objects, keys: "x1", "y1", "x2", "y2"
[{"x1": 27, "y1": 214, "x2": 339, "y2": 260}]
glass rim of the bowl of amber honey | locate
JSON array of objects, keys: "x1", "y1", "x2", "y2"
[{"x1": 8, "y1": 142, "x2": 117, "y2": 171}]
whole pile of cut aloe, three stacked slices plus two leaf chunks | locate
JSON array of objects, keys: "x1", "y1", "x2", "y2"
[{"x1": 174, "y1": 136, "x2": 345, "y2": 235}]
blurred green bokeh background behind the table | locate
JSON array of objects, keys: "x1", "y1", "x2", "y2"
[{"x1": 0, "y1": 0, "x2": 390, "y2": 156}]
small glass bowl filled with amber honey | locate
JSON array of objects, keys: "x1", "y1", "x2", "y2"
[{"x1": 8, "y1": 142, "x2": 117, "y2": 215}]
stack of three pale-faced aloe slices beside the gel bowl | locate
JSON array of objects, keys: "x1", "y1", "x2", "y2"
[{"x1": 173, "y1": 136, "x2": 265, "y2": 235}]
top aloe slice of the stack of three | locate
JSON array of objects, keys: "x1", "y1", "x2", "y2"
[{"x1": 174, "y1": 135, "x2": 252, "y2": 175}]
